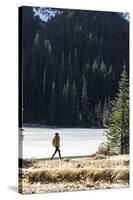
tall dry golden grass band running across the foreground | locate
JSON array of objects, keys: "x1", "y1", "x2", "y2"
[{"x1": 25, "y1": 167, "x2": 129, "y2": 184}]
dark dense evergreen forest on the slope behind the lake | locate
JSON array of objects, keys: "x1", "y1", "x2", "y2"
[{"x1": 22, "y1": 7, "x2": 129, "y2": 127}]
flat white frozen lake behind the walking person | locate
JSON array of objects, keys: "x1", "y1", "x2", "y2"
[{"x1": 19, "y1": 128, "x2": 106, "y2": 158}]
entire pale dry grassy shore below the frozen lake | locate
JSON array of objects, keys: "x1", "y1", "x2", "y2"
[{"x1": 19, "y1": 155, "x2": 129, "y2": 194}]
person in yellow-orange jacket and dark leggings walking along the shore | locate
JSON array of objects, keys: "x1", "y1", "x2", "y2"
[{"x1": 51, "y1": 133, "x2": 62, "y2": 160}]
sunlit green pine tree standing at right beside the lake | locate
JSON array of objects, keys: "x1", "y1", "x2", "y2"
[{"x1": 106, "y1": 66, "x2": 129, "y2": 154}]
